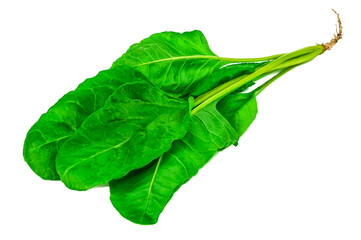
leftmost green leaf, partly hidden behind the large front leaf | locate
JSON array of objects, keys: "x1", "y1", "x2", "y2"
[{"x1": 23, "y1": 66, "x2": 144, "y2": 180}]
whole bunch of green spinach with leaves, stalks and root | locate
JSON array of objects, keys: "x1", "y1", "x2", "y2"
[{"x1": 23, "y1": 11, "x2": 342, "y2": 224}]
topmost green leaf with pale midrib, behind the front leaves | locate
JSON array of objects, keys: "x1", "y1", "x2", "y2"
[{"x1": 112, "y1": 30, "x2": 267, "y2": 98}]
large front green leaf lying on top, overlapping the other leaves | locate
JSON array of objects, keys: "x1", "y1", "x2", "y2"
[{"x1": 56, "y1": 79, "x2": 191, "y2": 190}]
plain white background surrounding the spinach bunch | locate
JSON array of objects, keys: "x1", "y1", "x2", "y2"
[{"x1": 0, "y1": 0, "x2": 361, "y2": 240}]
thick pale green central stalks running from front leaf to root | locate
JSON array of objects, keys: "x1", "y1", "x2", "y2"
[{"x1": 192, "y1": 45, "x2": 325, "y2": 114}]
